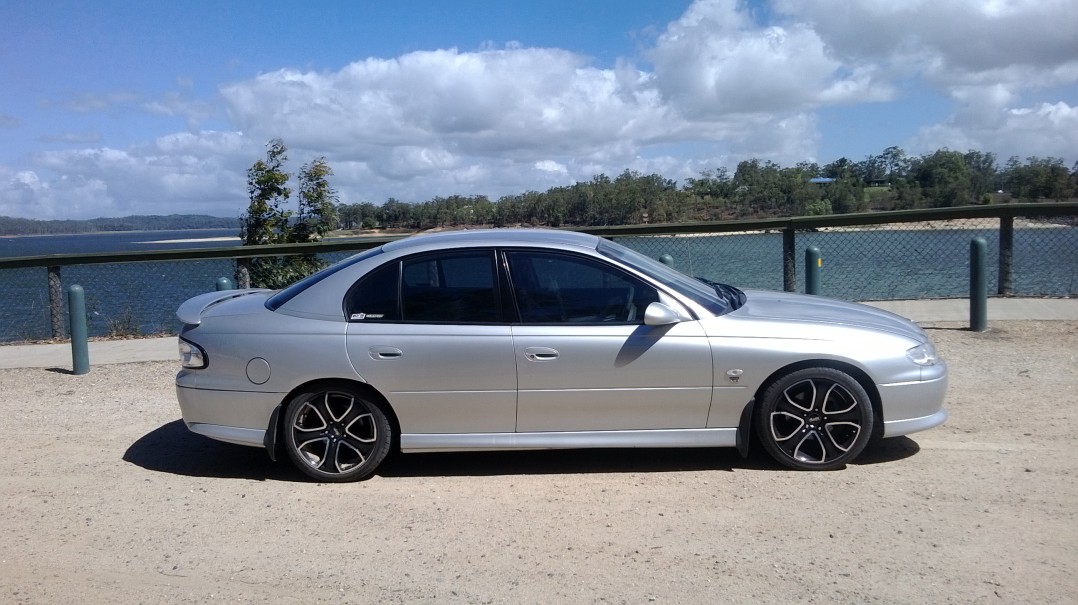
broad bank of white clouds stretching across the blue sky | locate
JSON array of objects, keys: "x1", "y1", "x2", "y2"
[{"x1": 0, "y1": 0, "x2": 1078, "y2": 217}]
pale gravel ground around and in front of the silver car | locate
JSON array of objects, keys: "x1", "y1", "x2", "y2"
[{"x1": 0, "y1": 321, "x2": 1078, "y2": 603}]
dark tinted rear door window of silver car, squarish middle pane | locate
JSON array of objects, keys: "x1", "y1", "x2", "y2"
[{"x1": 401, "y1": 251, "x2": 500, "y2": 324}]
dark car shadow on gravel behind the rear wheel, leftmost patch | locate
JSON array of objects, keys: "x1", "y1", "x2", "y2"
[{"x1": 123, "y1": 421, "x2": 306, "y2": 481}]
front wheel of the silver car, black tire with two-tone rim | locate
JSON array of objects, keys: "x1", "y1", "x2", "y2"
[{"x1": 756, "y1": 368, "x2": 874, "y2": 470}]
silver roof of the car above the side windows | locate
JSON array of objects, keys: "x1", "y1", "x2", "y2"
[{"x1": 382, "y1": 229, "x2": 599, "y2": 252}]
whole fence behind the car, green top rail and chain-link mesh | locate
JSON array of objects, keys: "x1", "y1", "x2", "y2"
[{"x1": 0, "y1": 203, "x2": 1078, "y2": 342}]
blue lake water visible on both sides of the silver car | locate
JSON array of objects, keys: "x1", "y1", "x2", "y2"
[{"x1": 0, "y1": 228, "x2": 1078, "y2": 342}]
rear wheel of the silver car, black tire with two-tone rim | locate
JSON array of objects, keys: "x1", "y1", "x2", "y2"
[{"x1": 282, "y1": 384, "x2": 393, "y2": 482}]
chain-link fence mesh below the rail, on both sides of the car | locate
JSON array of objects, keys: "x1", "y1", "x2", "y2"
[{"x1": 0, "y1": 207, "x2": 1078, "y2": 342}]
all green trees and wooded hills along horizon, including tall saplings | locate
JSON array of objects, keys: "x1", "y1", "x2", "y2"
[{"x1": 0, "y1": 139, "x2": 1078, "y2": 237}]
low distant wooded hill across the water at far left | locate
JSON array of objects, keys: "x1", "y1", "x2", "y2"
[{"x1": 0, "y1": 215, "x2": 239, "y2": 235}]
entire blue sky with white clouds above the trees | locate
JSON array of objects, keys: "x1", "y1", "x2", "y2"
[{"x1": 0, "y1": 0, "x2": 1078, "y2": 219}]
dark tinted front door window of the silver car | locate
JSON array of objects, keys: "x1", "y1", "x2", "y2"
[{"x1": 507, "y1": 251, "x2": 659, "y2": 324}]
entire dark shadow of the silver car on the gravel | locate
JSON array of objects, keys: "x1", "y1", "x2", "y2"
[{"x1": 123, "y1": 421, "x2": 920, "y2": 482}]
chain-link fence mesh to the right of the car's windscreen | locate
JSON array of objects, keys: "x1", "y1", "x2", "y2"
[{"x1": 616, "y1": 216, "x2": 1078, "y2": 301}]
